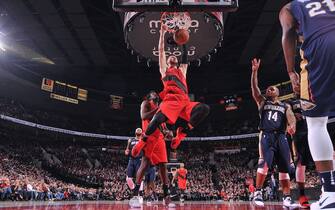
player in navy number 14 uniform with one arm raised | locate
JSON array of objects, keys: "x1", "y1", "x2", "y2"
[{"x1": 251, "y1": 59, "x2": 299, "y2": 209}]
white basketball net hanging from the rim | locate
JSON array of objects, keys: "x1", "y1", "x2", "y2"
[{"x1": 161, "y1": 12, "x2": 192, "y2": 33}]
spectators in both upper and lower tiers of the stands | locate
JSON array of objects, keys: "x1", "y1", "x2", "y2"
[{"x1": 0, "y1": 95, "x2": 335, "y2": 201}]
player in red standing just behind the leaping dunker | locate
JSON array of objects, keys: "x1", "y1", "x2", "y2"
[{"x1": 129, "y1": 91, "x2": 174, "y2": 207}]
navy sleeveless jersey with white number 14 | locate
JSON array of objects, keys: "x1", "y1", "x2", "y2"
[{"x1": 259, "y1": 100, "x2": 287, "y2": 133}]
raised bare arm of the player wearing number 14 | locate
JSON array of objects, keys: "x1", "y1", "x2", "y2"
[{"x1": 251, "y1": 58, "x2": 265, "y2": 108}]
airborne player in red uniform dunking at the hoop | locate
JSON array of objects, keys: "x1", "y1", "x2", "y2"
[{"x1": 143, "y1": 21, "x2": 209, "y2": 144}]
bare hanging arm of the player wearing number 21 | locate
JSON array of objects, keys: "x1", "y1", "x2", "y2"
[{"x1": 279, "y1": 3, "x2": 300, "y2": 93}]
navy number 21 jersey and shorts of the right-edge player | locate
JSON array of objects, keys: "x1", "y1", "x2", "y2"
[{"x1": 290, "y1": 0, "x2": 335, "y2": 117}]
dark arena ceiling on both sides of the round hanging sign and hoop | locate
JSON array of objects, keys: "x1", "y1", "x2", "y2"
[{"x1": 0, "y1": 0, "x2": 288, "y2": 100}]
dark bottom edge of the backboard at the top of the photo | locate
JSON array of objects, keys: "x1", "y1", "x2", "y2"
[{"x1": 113, "y1": 0, "x2": 238, "y2": 12}]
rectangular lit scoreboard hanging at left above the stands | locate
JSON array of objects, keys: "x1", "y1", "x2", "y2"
[{"x1": 41, "y1": 78, "x2": 88, "y2": 104}]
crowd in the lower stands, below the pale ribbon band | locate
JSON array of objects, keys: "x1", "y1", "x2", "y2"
[{"x1": 0, "y1": 130, "x2": 318, "y2": 201}]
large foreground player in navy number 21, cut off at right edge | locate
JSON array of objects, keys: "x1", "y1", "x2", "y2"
[{"x1": 280, "y1": 0, "x2": 335, "y2": 209}]
